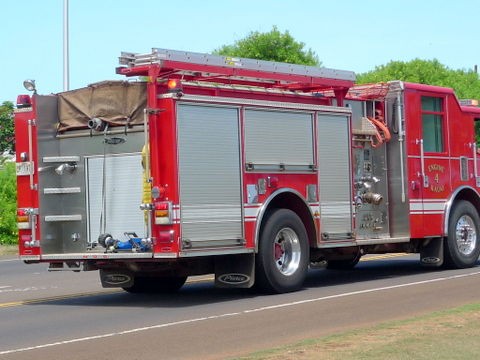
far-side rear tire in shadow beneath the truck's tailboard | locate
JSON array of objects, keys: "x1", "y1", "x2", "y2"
[{"x1": 123, "y1": 276, "x2": 187, "y2": 294}]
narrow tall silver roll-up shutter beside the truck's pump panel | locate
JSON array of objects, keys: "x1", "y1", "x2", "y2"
[{"x1": 317, "y1": 114, "x2": 352, "y2": 241}]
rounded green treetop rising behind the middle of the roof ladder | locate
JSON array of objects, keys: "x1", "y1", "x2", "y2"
[{"x1": 214, "y1": 26, "x2": 321, "y2": 66}]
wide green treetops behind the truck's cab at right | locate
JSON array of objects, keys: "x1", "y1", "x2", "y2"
[{"x1": 357, "y1": 59, "x2": 480, "y2": 99}]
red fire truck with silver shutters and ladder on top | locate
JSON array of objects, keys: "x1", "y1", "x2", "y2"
[{"x1": 15, "y1": 49, "x2": 480, "y2": 292}]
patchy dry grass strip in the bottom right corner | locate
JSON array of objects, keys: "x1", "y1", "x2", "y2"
[{"x1": 237, "y1": 303, "x2": 480, "y2": 360}]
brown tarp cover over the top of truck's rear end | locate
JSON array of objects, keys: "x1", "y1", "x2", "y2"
[{"x1": 58, "y1": 81, "x2": 147, "y2": 132}]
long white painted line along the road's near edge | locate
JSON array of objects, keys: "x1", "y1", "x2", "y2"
[{"x1": 0, "y1": 271, "x2": 480, "y2": 355}]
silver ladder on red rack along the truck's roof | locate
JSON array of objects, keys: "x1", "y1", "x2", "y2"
[{"x1": 117, "y1": 48, "x2": 355, "y2": 92}]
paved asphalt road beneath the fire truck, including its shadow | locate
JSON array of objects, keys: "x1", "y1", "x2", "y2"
[{"x1": 0, "y1": 256, "x2": 480, "y2": 360}]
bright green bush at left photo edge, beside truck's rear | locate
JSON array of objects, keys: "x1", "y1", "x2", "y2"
[{"x1": 0, "y1": 157, "x2": 18, "y2": 245}]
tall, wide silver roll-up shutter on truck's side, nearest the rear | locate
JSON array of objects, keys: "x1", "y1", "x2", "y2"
[{"x1": 177, "y1": 104, "x2": 244, "y2": 251}]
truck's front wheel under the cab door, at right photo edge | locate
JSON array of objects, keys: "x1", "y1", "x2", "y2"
[{"x1": 444, "y1": 200, "x2": 480, "y2": 269}]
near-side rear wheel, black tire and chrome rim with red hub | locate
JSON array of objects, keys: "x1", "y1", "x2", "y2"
[{"x1": 255, "y1": 209, "x2": 309, "y2": 293}]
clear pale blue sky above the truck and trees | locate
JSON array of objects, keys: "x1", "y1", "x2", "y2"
[{"x1": 0, "y1": 0, "x2": 480, "y2": 103}]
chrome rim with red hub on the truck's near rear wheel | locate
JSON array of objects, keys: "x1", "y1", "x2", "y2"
[{"x1": 273, "y1": 228, "x2": 302, "y2": 276}]
